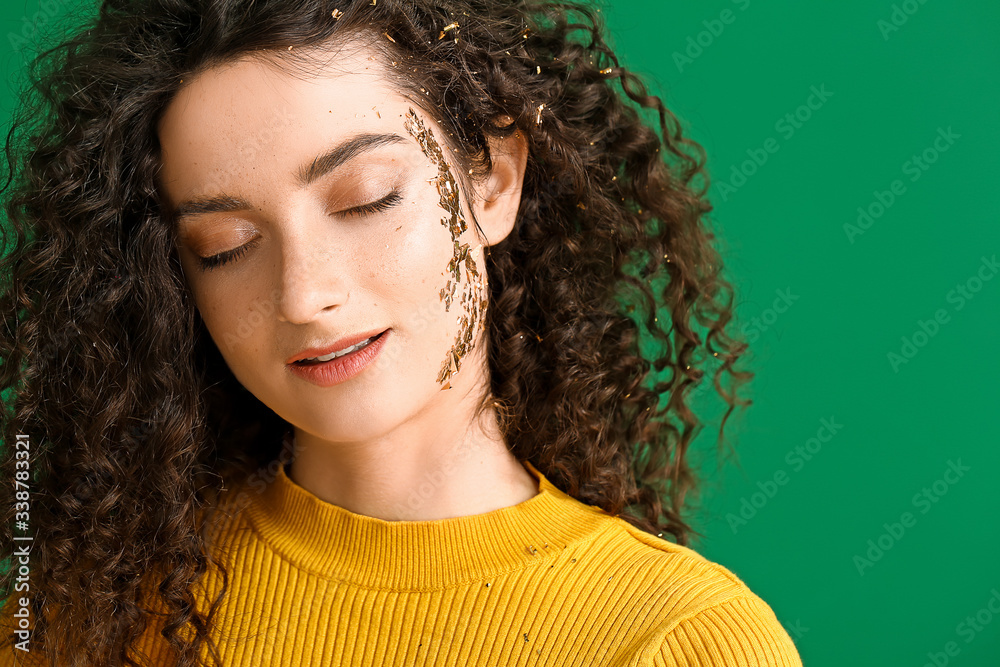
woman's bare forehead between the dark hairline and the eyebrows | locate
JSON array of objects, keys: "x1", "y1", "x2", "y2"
[{"x1": 157, "y1": 46, "x2": 419, "y2": 199}]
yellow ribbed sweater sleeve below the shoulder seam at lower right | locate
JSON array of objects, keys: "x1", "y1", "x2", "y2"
[{"x1": 653, "y1": 595, "x2": 802, "y2": 667}]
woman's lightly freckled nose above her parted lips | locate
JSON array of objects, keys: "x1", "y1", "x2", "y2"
[{"x1": 276, "y1": 227, "x2": 350, "y2": 324}]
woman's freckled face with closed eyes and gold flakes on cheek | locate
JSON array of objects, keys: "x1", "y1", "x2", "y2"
[{"x1": 159, "y1": 44, "x2": 523, "y2": 441}]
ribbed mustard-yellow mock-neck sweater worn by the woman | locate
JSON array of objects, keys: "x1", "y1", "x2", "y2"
[{"x1": 0, "y1": 463, "x2": 802, "y2": 667}]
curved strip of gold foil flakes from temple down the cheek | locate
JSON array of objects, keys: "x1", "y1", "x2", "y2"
[{"x1": 405, "y1": 108, "x2": 489, "y2": 389}]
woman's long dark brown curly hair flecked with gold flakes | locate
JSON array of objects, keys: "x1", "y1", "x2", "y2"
[{"x1": 0, "y1": 0, "x2": 753, "y2": 666}]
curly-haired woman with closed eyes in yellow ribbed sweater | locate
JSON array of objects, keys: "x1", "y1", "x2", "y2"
[{"x1": 0, "y1": 0, "x2": 801, "y2": 667}]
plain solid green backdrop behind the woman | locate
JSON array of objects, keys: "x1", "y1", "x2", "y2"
[{"x1": 0, "y1": 0, "x2": 1000, "y2": 667}]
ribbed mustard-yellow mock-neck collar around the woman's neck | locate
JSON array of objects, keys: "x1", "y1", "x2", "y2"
[{"x1": 247, "y1": 461, "x2": 609, "y2": 591}]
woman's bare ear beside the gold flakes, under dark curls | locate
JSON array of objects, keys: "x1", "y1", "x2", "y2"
[{"x1": 475, "y1": 125, "x2": 528, "y2": 245}]
